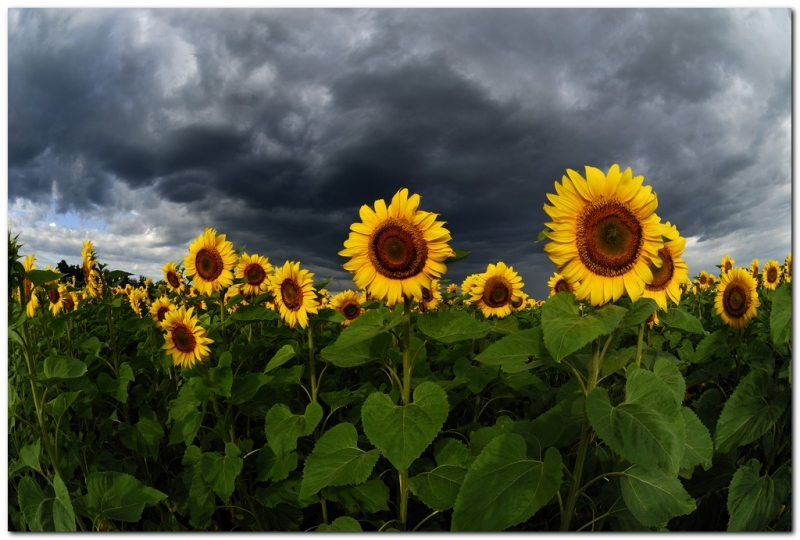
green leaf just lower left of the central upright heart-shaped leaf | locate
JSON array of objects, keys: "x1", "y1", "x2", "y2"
[{"x1": 300, "y1": 422, "x2": 380, "y2": 498}]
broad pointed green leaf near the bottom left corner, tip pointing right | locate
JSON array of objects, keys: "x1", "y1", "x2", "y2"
[{"x1": 80, "y1": 471, "x2": 167, "y2": 523}]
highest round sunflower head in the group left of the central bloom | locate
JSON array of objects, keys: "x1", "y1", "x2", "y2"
[{"x1": 183, "y1": 227, "x2": 237, "y2": 296}]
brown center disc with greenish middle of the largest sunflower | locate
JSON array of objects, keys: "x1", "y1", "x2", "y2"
[{"x1": 577, "y1": 199, "x2": 644, "y2": 277}]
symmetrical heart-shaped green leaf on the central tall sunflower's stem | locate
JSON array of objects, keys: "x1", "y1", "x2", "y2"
[{"x1": 361, "y1": 381, "x2": 450, "y2": 470}]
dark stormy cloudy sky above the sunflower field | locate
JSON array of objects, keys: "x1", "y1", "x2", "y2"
[{"x1": 8, "y1": 8, "x2": 792, "y2": 298}]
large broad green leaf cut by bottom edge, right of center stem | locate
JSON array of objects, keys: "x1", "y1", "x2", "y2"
[{"x1": 451, "y1": 433, "x2": 562, "y2": 531}]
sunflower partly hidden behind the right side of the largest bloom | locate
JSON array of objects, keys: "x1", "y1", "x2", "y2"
[{"x1": 642, "y1": 221, "x2": 689, "y2": 311}]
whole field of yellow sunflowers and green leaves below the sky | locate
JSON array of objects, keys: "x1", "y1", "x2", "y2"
[{"x1": 8, "y1": 165, "x2": 792, "y2": 532}]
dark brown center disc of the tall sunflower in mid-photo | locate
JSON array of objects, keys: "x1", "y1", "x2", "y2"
[{"x1": 369, "y1": 218, "x2": 428, "y2": 279}]
